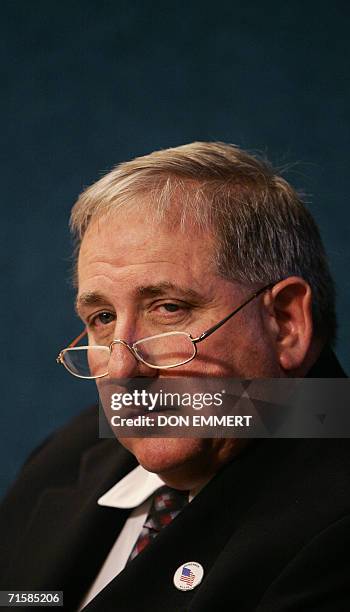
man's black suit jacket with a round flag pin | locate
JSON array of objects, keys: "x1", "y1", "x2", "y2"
[{"x1": 0, "y1": 350, "x2": 350, "y2": 612}]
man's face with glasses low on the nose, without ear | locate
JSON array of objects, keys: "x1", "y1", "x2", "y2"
[{"x1": 77, "y1": 213, "x2": 280, "y2": 488}]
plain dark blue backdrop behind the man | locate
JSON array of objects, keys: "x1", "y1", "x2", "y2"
[{"x1": 0, "y1": 0, "x2": 350, "y2": 492}]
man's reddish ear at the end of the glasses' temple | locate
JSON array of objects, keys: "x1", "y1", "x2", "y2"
[{"x1": 265, "y1": 276, "x2": 313, "y2": 371}]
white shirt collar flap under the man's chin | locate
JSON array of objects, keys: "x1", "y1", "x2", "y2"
[{"x1": 97, "y1": 465, "x2": 164, "y2": 509}]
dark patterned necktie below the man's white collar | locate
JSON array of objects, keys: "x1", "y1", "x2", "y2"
[{"x1": 128, "y1": 485, "x2": 188, "y2": 563}]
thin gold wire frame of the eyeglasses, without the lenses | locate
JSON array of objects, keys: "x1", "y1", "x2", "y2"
[{"x1": 56, "y1": 282, "x2": 276, "y2": 380}]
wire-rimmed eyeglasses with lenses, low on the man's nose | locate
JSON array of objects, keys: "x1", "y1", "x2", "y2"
[{"x1": 56, "y1": 283, "x2": 275, "y2": 379}]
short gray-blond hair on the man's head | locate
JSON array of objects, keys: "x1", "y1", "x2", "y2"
[{"x1": 71, "y1": 142, "x2": 336, "y2": 342}]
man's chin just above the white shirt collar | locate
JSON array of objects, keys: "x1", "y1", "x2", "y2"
[{"x1": 119, "y1": 438, "x2": 206, "y2": 476}]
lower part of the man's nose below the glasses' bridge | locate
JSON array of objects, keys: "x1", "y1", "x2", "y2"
[{"x1": 108, "y1": 338, "x2": 157, "y2": 378}]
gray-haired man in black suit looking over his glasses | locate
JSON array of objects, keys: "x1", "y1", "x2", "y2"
[{"x1": 1, "y1": 143, "x2": 350, "y2": 612}]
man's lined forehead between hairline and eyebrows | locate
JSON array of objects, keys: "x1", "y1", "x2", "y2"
[{"x1": 78, "y1": 214, "x2": 216, "y2": 291}]
